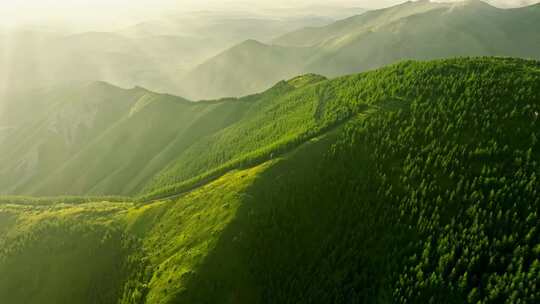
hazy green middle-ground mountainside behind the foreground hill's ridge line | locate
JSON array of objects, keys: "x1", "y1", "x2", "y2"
[{"x1": 0, "y1": 75, "x2": 330, "y2": 196}]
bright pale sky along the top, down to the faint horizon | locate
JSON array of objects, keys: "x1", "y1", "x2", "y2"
[{"x1": 0, "y1": 0, "x2": 540, "y2": 32}]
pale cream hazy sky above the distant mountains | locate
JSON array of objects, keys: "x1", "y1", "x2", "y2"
[{"x1": 0, "y1": 0, "x2": 540, "y2": 26}]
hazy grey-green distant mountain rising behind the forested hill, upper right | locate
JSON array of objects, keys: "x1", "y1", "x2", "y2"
[{"x1": 183, "y1": 0, "x2": 540, "y2": 98}]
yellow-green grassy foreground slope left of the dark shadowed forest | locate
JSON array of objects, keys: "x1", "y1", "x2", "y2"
[{"x1": 0, "y1": 163, "x2": 271, "y2": 303}]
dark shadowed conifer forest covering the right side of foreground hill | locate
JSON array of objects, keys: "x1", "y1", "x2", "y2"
[{"x1": 169, "y1": 56, "x2": 540, "y2": 303}]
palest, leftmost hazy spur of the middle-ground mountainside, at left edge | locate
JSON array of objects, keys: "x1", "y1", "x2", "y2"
[{"x1": 0, "y1": 82, "x2": 147, "y2": 193}]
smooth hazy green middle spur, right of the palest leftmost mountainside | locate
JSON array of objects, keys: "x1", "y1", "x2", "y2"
[{"x1": 34, "y1": 95, "x2": 253, "y2": 195}]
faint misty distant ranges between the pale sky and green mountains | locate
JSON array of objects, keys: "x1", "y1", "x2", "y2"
[{"x1": 0, "y1": 5, "x2": 363, "y2": 98}]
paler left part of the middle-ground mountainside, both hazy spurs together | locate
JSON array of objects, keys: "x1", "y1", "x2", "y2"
[{"x1": 0, "y1": 83, "x2": 252, "y2": 195}]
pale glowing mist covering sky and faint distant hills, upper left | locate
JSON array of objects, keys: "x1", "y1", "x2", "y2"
[{"x1": 0, "y1": 0, "x2": 538, "y2": 102}]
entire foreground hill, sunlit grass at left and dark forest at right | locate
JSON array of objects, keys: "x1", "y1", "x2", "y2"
[{"x1": 0, "y1": 58, "x2": 540, "y2": 304}]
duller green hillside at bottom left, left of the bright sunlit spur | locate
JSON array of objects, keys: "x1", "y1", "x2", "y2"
[{"x1": 0, "y1": 203, "x2": 139, "y2": 304}]
